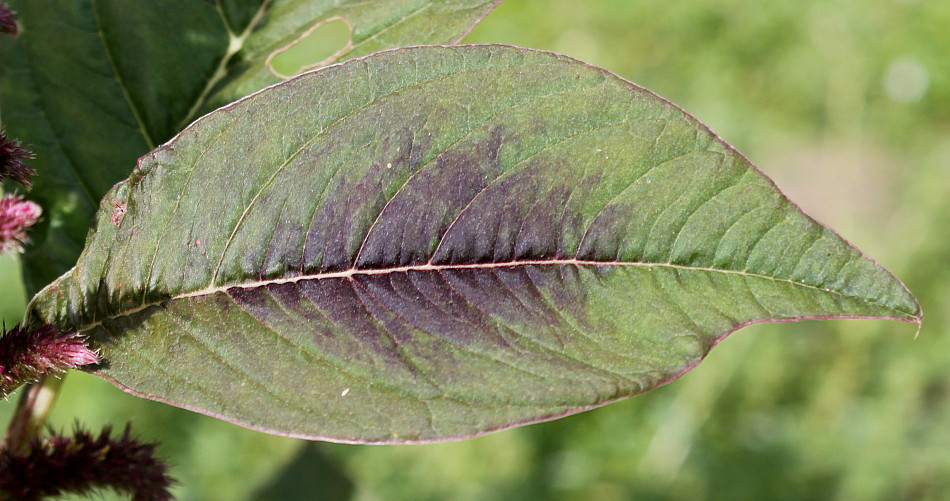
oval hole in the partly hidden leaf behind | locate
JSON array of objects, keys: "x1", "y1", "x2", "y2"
[{"x1": 267, "y1": 16, "x2": 353, "y2": 78}]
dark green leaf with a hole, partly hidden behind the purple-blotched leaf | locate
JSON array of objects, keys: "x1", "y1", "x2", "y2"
[{"x1": 0, "y1": 0, "x2": 500, "y2": 292}]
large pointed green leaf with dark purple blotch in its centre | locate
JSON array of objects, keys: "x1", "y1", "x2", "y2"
[{"x1": 33, "y1": 46, "x2": 920, "y2": 442}]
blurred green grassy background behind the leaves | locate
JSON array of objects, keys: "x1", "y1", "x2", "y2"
[{"x1": 0, "y1": 0, "x2": 950, "y2": 501}]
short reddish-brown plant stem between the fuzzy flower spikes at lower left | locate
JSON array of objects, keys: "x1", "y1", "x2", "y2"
[{"x1": 0, "y1": 374, "x2": 66, "y2": 452}]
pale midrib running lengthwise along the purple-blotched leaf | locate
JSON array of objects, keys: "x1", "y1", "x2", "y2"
[{"x1": 77, "y1": 258, "x2": 915, "y2": 333}]
